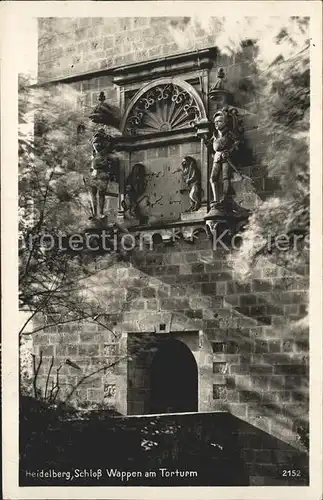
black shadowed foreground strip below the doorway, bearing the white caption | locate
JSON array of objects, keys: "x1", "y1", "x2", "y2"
[{"x1": 20, "y1": 398, "x2": 308, "y2": 486}]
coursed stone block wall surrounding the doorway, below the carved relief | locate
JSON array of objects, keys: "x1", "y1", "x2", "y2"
[{"x1": 35, "y1": 236, "x2": 308, "y2": 450}]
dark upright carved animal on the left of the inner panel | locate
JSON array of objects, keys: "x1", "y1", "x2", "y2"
[{"x1": 122, "y1": 163, "x2": 146, "y2": 220}]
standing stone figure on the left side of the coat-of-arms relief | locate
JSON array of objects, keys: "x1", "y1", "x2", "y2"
[{"x1": 90, "y1": 129, "x2": 118, "y2": 218}]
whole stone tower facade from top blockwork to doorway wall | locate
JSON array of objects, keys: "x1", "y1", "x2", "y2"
[{"x1": 35, "y1": 18, "x2": 308, "y2": 478}]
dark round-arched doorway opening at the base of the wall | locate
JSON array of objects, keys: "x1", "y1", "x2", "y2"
[{"x1": 150, "y1": 339, "x2": 198, "y2": 413}]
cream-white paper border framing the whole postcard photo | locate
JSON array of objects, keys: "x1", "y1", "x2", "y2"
[{"x1": 0, "y1": 1, "x2": 323, "y2": 500}]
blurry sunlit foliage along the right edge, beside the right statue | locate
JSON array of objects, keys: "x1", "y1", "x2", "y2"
[{"x1": 235, "y1": 45, "x2": 310, "y2": 275}]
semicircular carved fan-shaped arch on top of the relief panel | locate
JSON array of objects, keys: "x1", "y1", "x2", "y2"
[{"x1": 121, "y1": 78, "x2": 206, "y2": 137}]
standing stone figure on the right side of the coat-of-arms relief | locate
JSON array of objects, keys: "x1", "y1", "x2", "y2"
[{"x1": 207, "y1": 107, "x2": 242, "y2": 213}]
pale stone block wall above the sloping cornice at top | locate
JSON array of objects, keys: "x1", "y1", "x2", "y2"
[{"x1": 39, "y1": 17, "x2": 220, "y2": 80}]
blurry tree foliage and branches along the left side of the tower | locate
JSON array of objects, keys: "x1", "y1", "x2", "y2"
[{"x1": 19, "y1": 78, "x2": 121, "y2": 334}]
